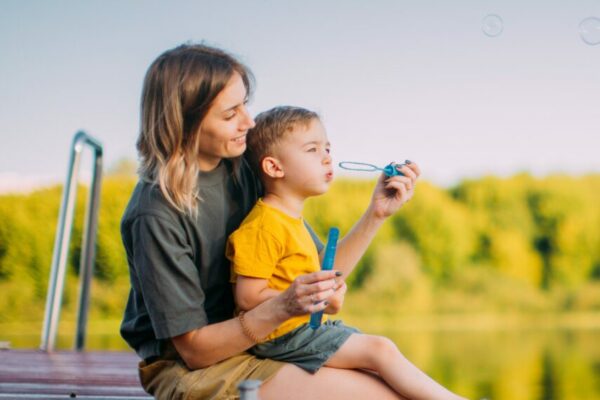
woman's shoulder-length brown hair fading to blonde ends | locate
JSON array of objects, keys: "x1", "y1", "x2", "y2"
[{"x1": 137, "y1": 44, "x2": 253, "y2": 215}]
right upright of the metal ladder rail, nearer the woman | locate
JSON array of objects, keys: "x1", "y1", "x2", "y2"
[{"x1": 75, "y1": 138, "x2": 102, "y2": 351}]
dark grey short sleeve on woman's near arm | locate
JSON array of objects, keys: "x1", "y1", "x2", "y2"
[{"x1": 132, "y1": 216, "x2": 208, "y2": 339}]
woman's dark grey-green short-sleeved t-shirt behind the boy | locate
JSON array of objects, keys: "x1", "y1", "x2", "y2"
[{"x1": 121, "y1": 160, "x2": 323, "y2": 358}]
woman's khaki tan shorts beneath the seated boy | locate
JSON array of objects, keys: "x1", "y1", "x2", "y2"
[{"x1": 139, "y1": 353, "x2": 285, "y2": 400}]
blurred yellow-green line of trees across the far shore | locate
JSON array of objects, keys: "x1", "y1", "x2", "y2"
[{"x1": 0, "y1": 174, "x2": 600, "y2": 321}]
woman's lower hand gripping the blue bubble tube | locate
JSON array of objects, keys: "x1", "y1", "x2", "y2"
[{"x1": 277, "y1": 271, "x2": 339, "y2": 319}]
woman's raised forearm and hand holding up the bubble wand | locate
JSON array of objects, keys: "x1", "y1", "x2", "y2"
[{"x1": 335, "y1": 162, "x2": 421, "y2": 278}]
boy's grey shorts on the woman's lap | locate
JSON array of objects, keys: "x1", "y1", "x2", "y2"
[{"x1": 249, "y1": 320, "x2": 360, "y2": 374}]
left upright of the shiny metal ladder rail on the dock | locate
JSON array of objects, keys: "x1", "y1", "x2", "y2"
[{"x1": 40, "y1": 131, "x2": 102, "y2": 351}]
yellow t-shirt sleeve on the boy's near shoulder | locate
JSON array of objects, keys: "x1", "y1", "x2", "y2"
[{"x1": 225, "y1": 227, "x2": 283, "y2": 279}]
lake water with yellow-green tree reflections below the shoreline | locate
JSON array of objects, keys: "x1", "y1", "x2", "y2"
[{"x1": 0, "y1": 329, "x2": 600, "y2": 400}]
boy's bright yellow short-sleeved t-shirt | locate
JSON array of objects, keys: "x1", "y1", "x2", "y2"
[{"x1": 226, "y1": 199, "x2": 321, "y2": 340}]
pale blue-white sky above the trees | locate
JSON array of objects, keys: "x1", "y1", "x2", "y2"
[{"x1": 0, "y1": 0, "x2": 600, "y2": 191}]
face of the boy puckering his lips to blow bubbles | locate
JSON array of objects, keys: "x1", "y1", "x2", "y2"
[{"x1": 275, "y1": 119, "x2": 333, "y2": 198}]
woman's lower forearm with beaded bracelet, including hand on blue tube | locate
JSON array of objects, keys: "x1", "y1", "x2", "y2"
[{"x1": 171, "y1": 271, "x2": 336, "y2": 369}]
